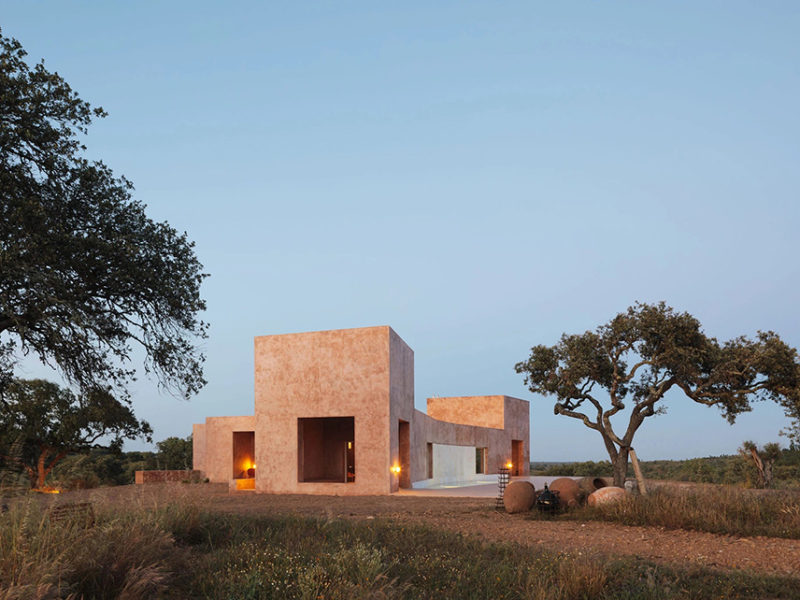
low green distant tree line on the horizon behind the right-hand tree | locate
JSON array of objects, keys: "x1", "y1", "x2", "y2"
[{"x1": 531, "y1": 445, "x2": 800, "y2": 487}]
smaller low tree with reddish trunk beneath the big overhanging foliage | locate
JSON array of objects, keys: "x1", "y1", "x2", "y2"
[{"x1": 0, "y1": 379, "x2": 152, "y2": 488}]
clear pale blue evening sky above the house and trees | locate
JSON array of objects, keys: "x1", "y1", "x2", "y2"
[{"x1": 0, "y1": 0, "x2": 800, "y2": 460}]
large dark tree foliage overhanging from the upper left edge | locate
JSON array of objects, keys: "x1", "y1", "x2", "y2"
[{"x1": 0, "y1": 34, "x2": 207, "y2": 397}]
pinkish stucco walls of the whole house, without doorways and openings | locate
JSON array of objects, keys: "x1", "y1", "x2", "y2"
[{"x1": 193, "y1": 326, "x2": 530, "y2": 495}]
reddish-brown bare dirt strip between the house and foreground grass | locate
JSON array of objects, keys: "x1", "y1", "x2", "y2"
[{"x1": 64, "y1": 484, "x2": 800, "y2": 578}]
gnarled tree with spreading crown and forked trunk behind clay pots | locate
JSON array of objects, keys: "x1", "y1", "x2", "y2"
[{"x1": 516, "y1": 302, "x2": 800, "y2": 485}]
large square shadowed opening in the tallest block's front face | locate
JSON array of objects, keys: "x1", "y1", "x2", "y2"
[{"x1": 297, "y1": 417, "x2": 356, "y2": 483}]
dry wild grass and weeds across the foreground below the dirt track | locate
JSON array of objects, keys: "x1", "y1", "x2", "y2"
[{"x1": 0, "y1": 488, "x2": 798, "y2": 600}]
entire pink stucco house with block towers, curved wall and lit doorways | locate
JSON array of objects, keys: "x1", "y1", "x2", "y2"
[{"x1": 193, "y1": 326, "x2": 530, "y2": 495}]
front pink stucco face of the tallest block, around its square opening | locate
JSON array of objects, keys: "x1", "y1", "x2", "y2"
[{"x1": 255, "y1": 326, "x2": 399, "y2": 495}]
